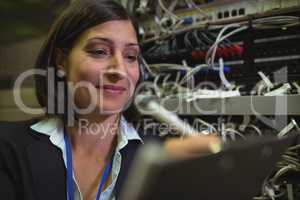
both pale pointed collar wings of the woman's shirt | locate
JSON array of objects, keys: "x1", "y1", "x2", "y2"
[{"x1": 30, "y1": 116, "x2": 143, "y2": 150}]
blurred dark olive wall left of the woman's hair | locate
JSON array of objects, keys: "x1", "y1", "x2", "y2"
[{"x1": 0, "y1": 0, "x2": 70, "y2": 121}]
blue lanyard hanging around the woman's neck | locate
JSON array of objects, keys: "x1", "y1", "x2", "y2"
[{"x1": 64, "y1": 131, "x2": 114, "y2": 200}]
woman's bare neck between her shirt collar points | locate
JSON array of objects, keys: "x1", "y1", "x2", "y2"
[{"x1": 67, "y1": 115, "x2": 119, "y2": 160}]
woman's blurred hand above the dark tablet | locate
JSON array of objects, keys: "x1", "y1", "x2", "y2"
[{"x1": 164, "y1": 135, "x2": 221, "y2": 159}]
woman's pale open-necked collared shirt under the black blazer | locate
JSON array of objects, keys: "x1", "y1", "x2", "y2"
[{"x1": 30, "y1": 116, "x2": 142, "y2": 200}]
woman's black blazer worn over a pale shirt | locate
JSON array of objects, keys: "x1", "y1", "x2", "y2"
[{"x1": 0, "y1": 120, "x2": 141, "y2": 200}]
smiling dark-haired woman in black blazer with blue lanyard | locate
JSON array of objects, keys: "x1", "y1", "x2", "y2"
[{"x1": 0, "y1": 0, "x2": 219, "y2": 200}]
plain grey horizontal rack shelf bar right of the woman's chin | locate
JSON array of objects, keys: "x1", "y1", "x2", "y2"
[{"x1": 159, "y1": 95, "x2": 300, "y2": 115}]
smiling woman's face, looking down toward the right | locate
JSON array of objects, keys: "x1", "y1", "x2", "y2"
[{"x1": 62, "y1": 20, "x2": 140, "y2": 114}]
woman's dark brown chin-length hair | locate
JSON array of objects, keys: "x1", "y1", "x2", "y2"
[{"x1": 35, "y1": 0, "x2": 141, "y2": 122}]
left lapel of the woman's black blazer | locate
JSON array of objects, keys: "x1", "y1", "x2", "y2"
[{"x1": 27, "y1": 130, "x2": 67, "y2": 200}]
